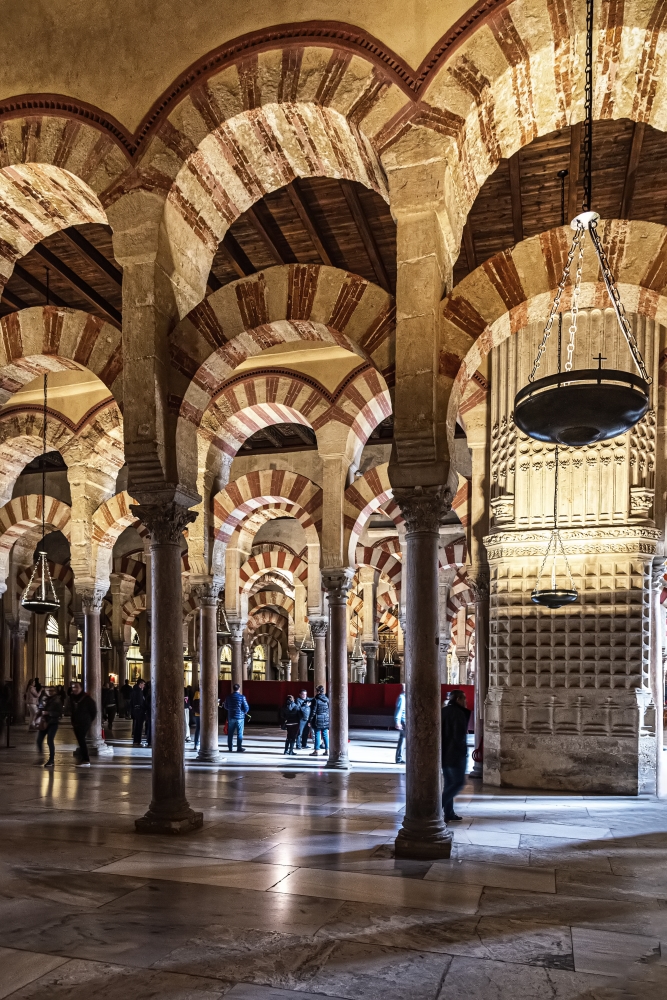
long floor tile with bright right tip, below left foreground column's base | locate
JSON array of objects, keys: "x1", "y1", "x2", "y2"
[{"x1": 97, "y1": 851, "x2": 294, "y2": 891}]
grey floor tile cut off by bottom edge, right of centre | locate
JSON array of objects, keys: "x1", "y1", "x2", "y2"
[{"x1": 438, "y1": 958, "x2": 608, "y2": 1000}]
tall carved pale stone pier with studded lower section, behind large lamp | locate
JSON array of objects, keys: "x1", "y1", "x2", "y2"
[{"x1": 484, "y1": 309, "x2": 663, "y2": 795}]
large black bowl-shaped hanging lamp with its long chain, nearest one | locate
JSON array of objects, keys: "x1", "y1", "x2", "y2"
[{"x1": 514, "y1": 0, "x2": 652, "y2": 447}]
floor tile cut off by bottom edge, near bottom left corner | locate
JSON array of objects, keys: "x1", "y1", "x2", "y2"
[{"x1": 5, "y1": 959, "x2": 232, "y2": 1000}]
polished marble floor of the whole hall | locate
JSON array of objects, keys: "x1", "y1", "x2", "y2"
[{"x1": 0, "y1": 723, "x2": 667, "y2": 1000}]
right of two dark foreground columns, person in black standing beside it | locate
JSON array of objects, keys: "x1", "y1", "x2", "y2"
[{"x1": 394, "y1": 486, "x2": 452, "y2": 859}]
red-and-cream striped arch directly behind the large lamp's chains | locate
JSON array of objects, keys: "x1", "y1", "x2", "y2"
[{"x1": 440, "y1": 220, "x2": 667, "y2": 422}]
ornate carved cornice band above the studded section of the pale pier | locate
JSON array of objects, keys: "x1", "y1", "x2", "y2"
[{"x1": 484, "y1": 525, "x2": 662, "y2": 561}]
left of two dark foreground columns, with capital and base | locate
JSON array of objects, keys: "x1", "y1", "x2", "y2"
[{"x1": 131, "y1": 500, "x2": 203, "y2": 834}]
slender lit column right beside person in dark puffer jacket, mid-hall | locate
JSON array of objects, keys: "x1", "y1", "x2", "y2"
[{"x1": 324, "y1": 567, "x2": 354, "y2": 770}]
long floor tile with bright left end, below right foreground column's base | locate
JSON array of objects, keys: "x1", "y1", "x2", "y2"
[{"x1": 269, "y1": 868, "x2": 482, "y2": 913}]
